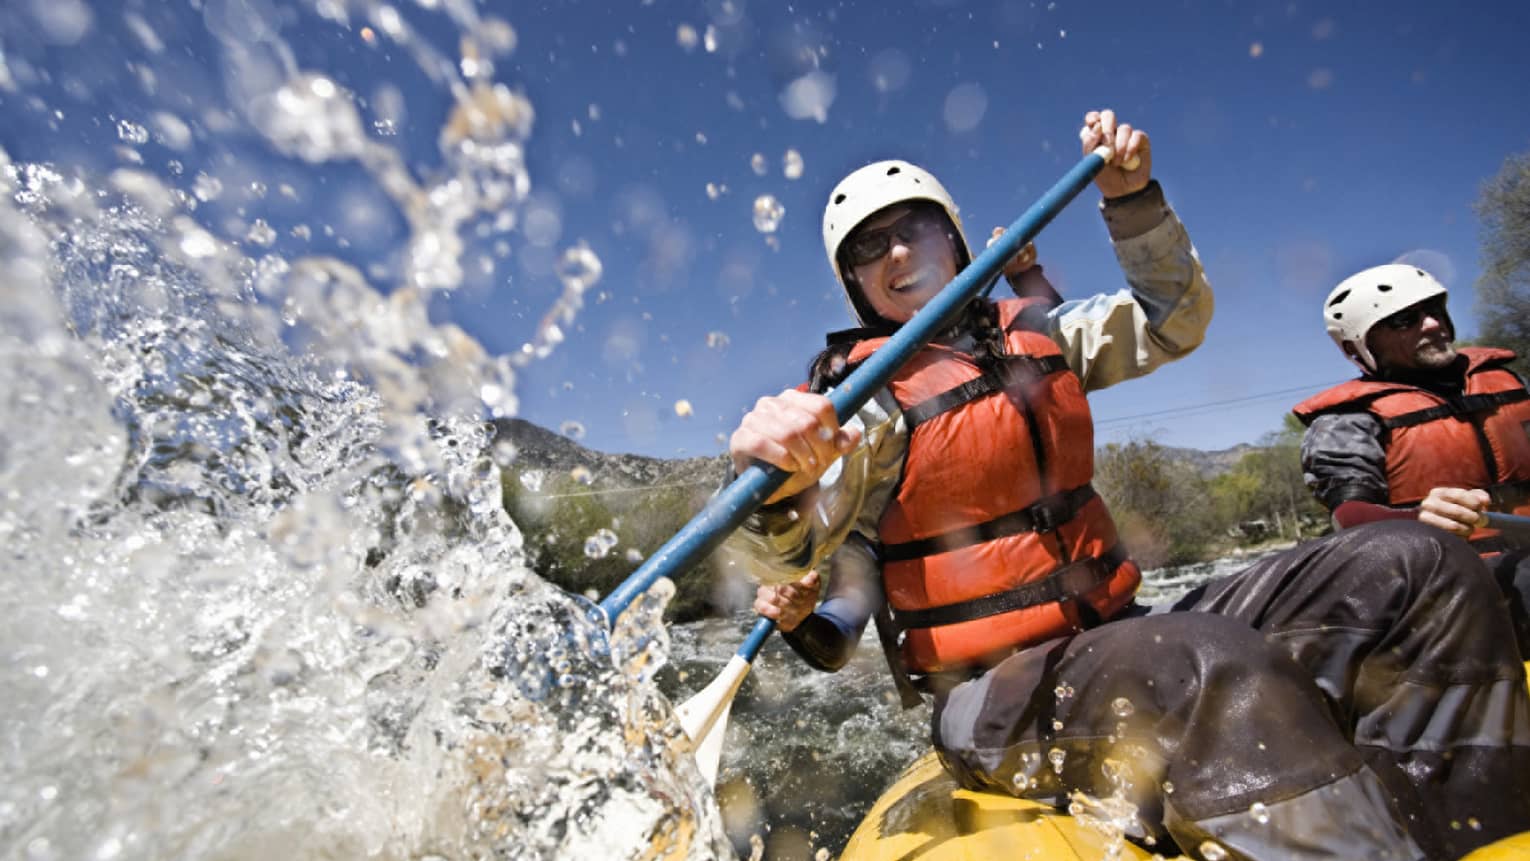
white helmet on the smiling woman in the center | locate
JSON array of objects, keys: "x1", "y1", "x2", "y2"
[{"x1": 823, "y1": 159, "x2": 972, "y2": 324}]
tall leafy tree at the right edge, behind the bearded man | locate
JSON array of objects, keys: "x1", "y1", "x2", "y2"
[{"x1": 1475, "y1": 153, "x2": 1530, "y2": 372}]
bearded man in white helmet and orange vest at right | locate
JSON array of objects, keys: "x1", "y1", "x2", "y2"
[{"x1": 1294, "y1": 263, "x2": 1530, "y2": 653}]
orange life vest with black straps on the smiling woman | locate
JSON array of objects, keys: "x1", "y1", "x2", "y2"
[{"x1": 849, "y1": 300, "x2": 1141, "y2": 673}]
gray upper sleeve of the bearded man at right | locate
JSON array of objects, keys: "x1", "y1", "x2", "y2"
[{"x1": 1302, "y1": 411, "x2": 1388, "y2": 511}]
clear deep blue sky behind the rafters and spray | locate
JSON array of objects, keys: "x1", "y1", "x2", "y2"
[{"x1": 0, "y1": 0, "x2": 1530, "y2": 457}]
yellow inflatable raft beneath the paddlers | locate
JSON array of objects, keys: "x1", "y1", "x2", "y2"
[{"x1": 840, "y1": 664, "x2": 1530, "y2": 861}]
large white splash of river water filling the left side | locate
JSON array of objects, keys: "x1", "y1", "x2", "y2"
[{"x1": 0, "y1": 0, "x2": 730, "y2": 858}]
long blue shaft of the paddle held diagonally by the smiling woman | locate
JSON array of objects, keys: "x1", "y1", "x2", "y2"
[{"x1": 600, "y1": 151, "x2": 1105, "y2": 627}]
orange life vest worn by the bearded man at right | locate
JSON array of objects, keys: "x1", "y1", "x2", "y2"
[{"x1": 1293, "y1": 347, "x2": 1530, "y2": 541}]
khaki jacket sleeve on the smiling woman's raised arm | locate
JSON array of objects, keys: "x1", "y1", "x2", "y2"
[{"x1": 1047, "y1": 182, "x2": 1212, "y2": 392}]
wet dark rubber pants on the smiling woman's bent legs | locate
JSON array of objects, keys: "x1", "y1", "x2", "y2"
[{"x1": 935, "y1": 521, "x2": 1530, "y2": 859}]
